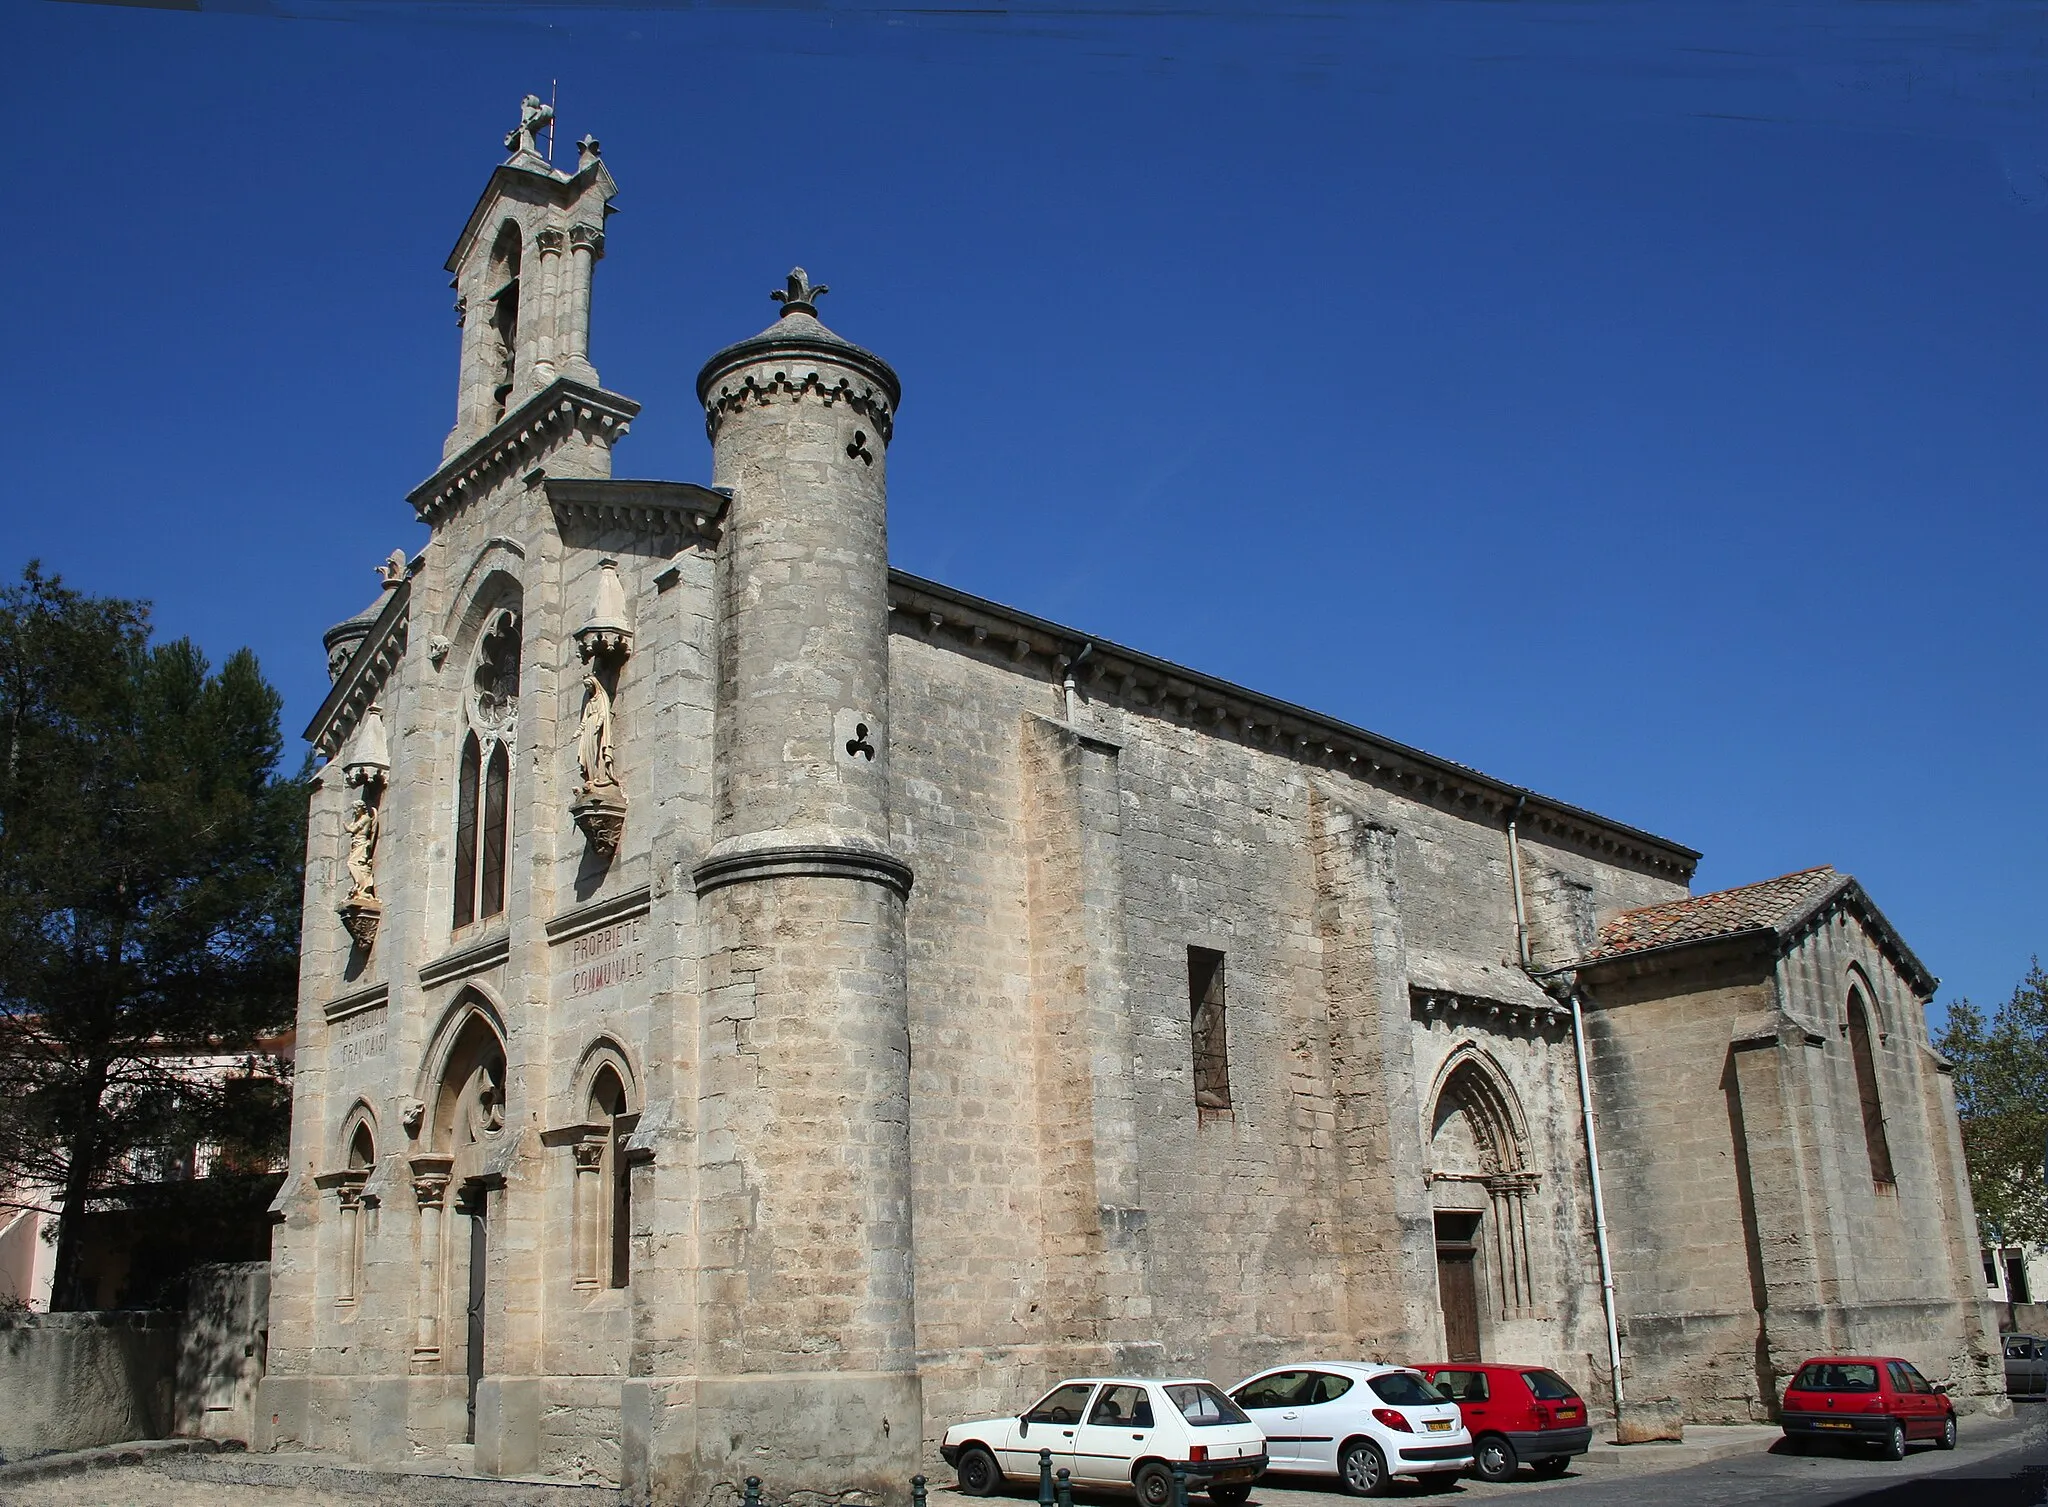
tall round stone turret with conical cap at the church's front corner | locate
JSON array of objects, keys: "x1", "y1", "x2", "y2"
[{"x1": 679, "y1": 268, "x2": 924, "y2": 1501}]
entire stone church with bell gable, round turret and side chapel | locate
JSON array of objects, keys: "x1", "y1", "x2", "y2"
[{"x1": 256, "y1": 100, "x2": 2003, "y2": 1503}]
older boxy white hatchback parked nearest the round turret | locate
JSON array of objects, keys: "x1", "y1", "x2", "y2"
[{"x1": 938, "y1": 1376, "x2": 1261, "y2": 1507}]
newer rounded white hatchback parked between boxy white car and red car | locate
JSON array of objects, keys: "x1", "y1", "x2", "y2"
[{"x1": 1231, "y1": 1362, "x2": 1473, "y2": 1497}]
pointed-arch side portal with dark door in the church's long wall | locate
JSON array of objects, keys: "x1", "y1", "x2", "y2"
[{"x1": 1427, "y1": 1042, "x2": 1538, "y2": 1360}]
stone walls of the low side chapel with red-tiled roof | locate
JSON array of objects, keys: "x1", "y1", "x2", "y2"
[{"x1": 1587, "y1": 919, "x2": 2003, "y2": 1421}]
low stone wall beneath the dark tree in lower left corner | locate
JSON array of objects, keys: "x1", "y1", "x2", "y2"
[{"x1": 0, "y1": 1312, "x2": 178, "y2": 1460}]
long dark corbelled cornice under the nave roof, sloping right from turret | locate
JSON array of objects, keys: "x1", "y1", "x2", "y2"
[{"x1": 889, "y1": 569, "x2": 1700, "y2": 885}]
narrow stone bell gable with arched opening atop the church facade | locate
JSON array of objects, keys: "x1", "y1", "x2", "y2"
[{"x1": 442, "y1": 94, "x2": 618, "y2": 459}]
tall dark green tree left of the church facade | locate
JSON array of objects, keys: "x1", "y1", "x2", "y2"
[{"x1": 0, "y1": 563, "x2": 305, "y2": 1308}]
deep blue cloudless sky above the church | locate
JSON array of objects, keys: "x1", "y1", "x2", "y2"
[{"x1": 0, "y1": 0, "x2": 2048, "y2": 1023}]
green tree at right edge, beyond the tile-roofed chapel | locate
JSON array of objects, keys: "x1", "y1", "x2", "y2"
[{"x1": 1935, "y1": 958, "x2": 2048, "y2": 1245}]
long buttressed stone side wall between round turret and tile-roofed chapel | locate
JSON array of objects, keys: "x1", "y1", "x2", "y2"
[{"x1": 891, "y1": 614, "x2": 1681, "y2": 1431}]
